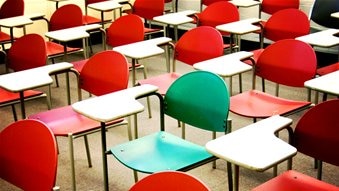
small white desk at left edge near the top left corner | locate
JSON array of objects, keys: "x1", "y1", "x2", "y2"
[{"x1": 0, "y1": 16, "x2": 33, "y2": 43}]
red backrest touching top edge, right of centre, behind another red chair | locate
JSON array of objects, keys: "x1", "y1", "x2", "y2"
[{"x1": 197, "y1": 1, "x2": 240, "y2": 35}]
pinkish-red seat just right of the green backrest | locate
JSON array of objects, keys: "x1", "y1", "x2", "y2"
[{"x1": 230, "y1": 90, "x2": 311, "y2": 118}]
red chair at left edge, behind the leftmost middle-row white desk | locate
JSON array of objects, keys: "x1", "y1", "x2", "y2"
[{"x1": 0, "y1": 34, "x2": 51, "y2": 121}]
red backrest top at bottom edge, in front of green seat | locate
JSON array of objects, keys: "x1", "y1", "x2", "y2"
[{"x1": 129, "y1": 171, "x2": 210, "y2": 191}]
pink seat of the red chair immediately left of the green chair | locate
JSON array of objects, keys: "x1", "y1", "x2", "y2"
[{"x1": 28, "y1": 106, "x2": 123, "y2": 136}]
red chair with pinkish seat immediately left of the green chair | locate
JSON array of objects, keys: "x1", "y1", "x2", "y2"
[{"x1": 28, "y1": 50, "x2": 131, "y2": 190}]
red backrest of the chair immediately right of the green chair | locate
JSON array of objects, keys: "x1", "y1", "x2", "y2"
[{"x1": 255, "y1": 39, "x2": 317, "y2": 87}]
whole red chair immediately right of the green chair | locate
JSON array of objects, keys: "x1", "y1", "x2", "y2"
[{"x1": 230, "y1": 39, "x2": 317, "y2": 121}]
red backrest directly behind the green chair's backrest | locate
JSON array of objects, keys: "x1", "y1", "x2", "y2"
[{"x1": 174, "y1": 26, "x2": 224, "y2": 65}]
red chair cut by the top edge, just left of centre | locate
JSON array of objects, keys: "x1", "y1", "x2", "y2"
[{"x1": 124, "y1": 0, "x2": 165, "y2": 36}]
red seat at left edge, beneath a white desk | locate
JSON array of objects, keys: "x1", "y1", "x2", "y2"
[{"x1": 0, "y1": 88, "x2": 44, "y2": 104}]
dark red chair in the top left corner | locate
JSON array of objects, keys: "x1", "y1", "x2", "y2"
[{"x1": 0, "y1": 0, "x2": 25, "y2": 50}]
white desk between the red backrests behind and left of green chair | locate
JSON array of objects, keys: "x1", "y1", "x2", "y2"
[{"x1": 113, "y1": 37, "x2": 172, "y2": 86}]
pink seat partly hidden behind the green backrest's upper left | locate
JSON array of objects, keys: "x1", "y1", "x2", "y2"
[{"x1": 138, "y1": 73, "x2": 180, "y2": 95}]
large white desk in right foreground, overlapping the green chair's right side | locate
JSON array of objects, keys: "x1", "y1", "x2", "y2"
[{"x1": 206, "y1": 115, "x2": 297, "y2": 190}]
